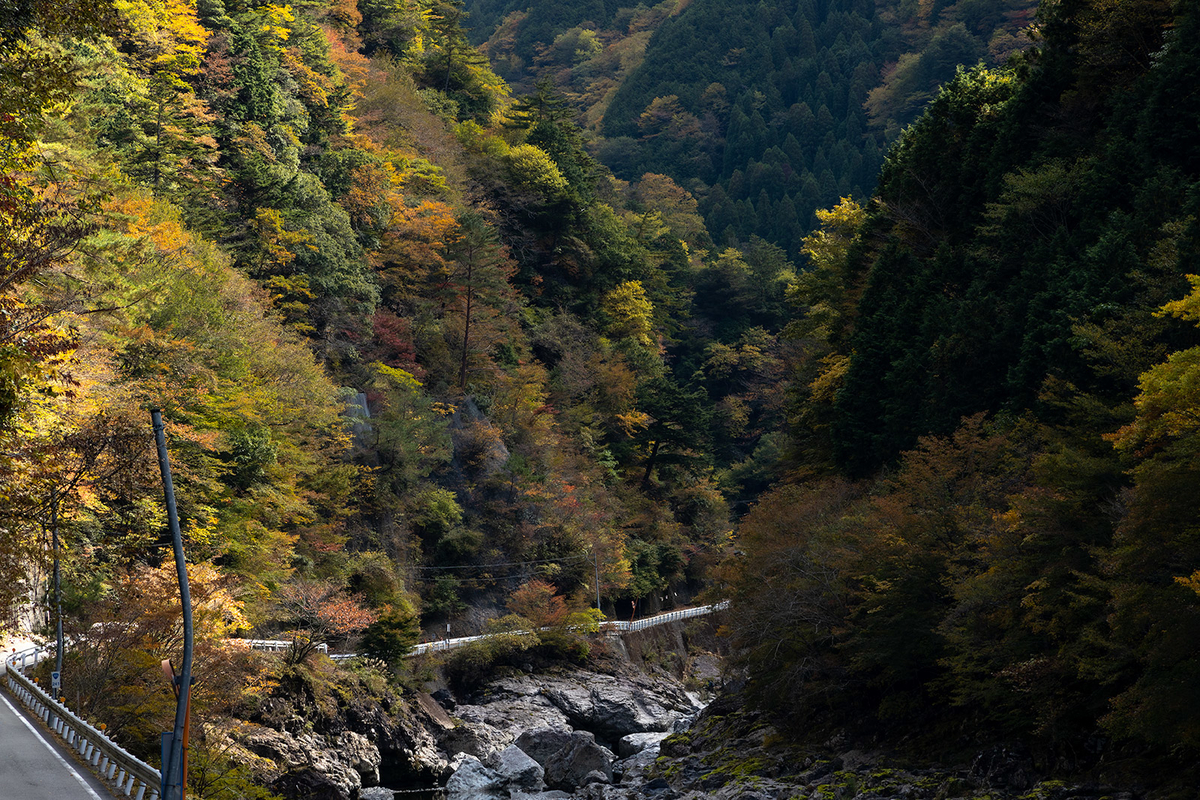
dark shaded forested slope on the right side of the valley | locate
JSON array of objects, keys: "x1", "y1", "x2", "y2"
[{"x1": 731, "y1": 1, "x2": 1200, "y2": 796}]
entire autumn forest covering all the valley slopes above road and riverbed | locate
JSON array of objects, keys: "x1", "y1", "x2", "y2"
[{"x1": 0, "y1": 0, "x2": 1200, "y2": 800}]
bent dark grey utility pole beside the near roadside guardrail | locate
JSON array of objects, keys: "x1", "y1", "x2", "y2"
[{"x1": 150, "y1": 409, "x2": 192, "y2": 800}]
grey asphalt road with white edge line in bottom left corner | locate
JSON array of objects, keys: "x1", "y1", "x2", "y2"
[{"x1": 0, "y1": 691, "x2": 113, "y2": 800}]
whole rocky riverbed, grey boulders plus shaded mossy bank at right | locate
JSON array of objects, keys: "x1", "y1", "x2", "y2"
[{"x1": 230, "y1": 660, "x2": 1140, "y2": 800}]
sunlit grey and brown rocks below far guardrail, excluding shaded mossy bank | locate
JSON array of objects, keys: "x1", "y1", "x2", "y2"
[{"x1": 229, "y1": 631, "x2": 715, "y2": 800}]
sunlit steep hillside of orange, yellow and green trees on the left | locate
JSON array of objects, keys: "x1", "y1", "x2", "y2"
[{"x1": 0, "y1": 0, "x2": 748, "y2": 782}]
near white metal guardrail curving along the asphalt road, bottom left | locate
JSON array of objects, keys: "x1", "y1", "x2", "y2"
[{"x1": 5, "y1": 646, "x2": 162, "y2": 800}]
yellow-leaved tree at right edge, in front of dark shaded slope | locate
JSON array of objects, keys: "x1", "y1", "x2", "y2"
[{"x1": 1105, "y1": 251, "x2": 1200, "y2": 747}]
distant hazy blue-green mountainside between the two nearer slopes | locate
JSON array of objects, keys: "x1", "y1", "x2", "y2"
[{"x1": 467, "y1": 0, "x2": 1036, "y2": 259}]
